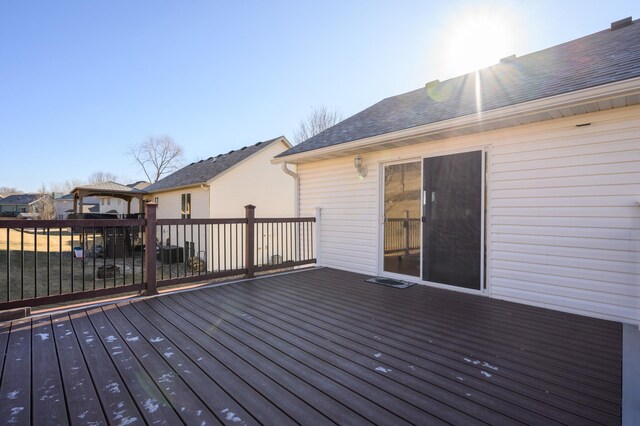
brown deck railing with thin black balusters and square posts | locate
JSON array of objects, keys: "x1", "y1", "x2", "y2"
[{"x1": 0, "y1": 203, "x2": 315, "y2": 310}]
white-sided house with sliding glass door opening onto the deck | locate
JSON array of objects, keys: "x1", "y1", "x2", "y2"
[{"x1": 274, "y1": 18, "x2": 640, "y2": 324}]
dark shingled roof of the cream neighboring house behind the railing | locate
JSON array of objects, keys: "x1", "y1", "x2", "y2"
[{"x1": 145, "y1": 136, "x2": 289, "y2": 192}]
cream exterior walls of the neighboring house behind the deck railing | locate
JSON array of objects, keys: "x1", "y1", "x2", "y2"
[{"x1": 148, "y1": 141, "x2": 295, "y2": 271}]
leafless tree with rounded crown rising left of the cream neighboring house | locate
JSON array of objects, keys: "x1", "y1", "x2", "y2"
[{"x1": 129, "y1": 136, "x2": 183, "y2": 183}]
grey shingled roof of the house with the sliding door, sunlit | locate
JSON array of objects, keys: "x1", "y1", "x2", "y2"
[{"x1": 277, "y1": 18, "x2": 640, "y2": 157}]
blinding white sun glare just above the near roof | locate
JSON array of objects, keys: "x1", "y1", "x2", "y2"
[{"x1": 438, "y1": 10, "x2": 519, "y2": 80}]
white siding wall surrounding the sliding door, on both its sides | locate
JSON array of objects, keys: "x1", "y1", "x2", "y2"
[{"x1": 299, "y1": 107, "x2": 640, "y2": 323}]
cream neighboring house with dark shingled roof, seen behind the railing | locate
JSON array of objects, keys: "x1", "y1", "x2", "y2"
[{"x1": 144, "y1": 136, "x2": 295, "y2": 270}]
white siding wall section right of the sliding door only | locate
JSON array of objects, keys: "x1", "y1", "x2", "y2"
[{"x1": 491, "y1": 107, "x2": 640, "y2": 323}]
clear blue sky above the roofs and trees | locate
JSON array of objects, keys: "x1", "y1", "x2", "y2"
[{"x1": 0, "y1": 0, "x2": 640, "y2": 191}]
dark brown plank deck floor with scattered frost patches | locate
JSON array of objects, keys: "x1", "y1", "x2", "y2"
[{"x1": 0, "y1": 269, "x2": 622, "y2": 425}]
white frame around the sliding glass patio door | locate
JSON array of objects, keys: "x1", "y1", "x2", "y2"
[{"x1": 376, "y1": 145, "x2": 491, "y2": 295}]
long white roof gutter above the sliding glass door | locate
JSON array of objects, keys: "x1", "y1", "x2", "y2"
[{"x1": 271, "y1": 77, "x2": 640, "y2": 164}]
